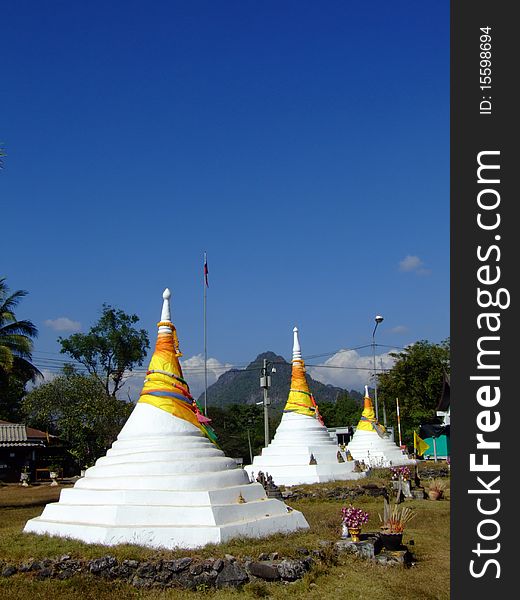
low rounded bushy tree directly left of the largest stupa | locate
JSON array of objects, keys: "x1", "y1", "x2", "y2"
[{"x1": 21, "y1": 373, "x2": 134, "y2": 467}]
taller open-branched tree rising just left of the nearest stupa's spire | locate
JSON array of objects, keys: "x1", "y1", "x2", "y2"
[{"x1": 58, "y1": 304, "x2": 150, "y2": 396}]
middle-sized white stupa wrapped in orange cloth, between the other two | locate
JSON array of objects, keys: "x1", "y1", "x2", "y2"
[{"x1": 245, "y1": 327, "x2": 366, "y2": 486}]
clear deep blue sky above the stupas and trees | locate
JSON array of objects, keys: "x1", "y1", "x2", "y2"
[{"x1": 0, "y1": 0, "x2": 449, "y2": 398}]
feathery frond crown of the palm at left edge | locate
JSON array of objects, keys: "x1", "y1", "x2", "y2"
[{"x1": 0, "y1": 277, "x2": 42, "y2": 382}]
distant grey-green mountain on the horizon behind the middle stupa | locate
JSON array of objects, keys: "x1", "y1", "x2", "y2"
[{"x1": 199, "y1": 352, "x2": 362, "y2": 409}]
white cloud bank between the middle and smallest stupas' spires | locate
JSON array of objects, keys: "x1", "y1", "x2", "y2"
[{"x1": 307, "y1": 350, "x2": 394, "y2": 392}]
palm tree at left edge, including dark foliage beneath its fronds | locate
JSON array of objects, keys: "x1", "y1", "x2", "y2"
[{"x1": 0, "y1": 277, "x2": 42, "y2": 419}]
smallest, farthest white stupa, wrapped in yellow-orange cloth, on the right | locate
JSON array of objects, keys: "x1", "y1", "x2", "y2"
[{"x1": 347, "y1": 386, "x2": 416, "y2": 467}]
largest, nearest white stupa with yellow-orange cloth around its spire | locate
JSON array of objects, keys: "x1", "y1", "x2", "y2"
[{"x1": 24, "y1": 290, "x2": 309, "y2": 549}]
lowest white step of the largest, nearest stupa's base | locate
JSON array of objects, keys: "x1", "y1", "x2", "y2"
[{"x1": 24, "y1": 508, "x2": 309, "y2": 550}]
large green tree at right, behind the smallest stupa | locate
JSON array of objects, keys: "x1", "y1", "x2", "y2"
[{"x1": 378, "y1": 338, "x2": 450, "y2": 445}]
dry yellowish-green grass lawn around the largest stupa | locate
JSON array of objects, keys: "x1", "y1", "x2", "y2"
[{"x1": 0, "y1": 480, "x2": 450, "y2": 600}]
